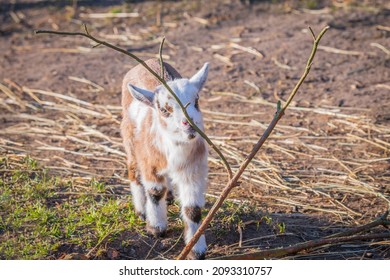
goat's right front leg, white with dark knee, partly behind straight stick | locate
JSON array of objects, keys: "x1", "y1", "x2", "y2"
[{"x1": 179, "y1": 179, "x2": 207, "y2": 259}]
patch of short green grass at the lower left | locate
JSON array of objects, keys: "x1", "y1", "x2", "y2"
[{"x1": 0, "y1": 156, "x2": 143, "y2": 259}]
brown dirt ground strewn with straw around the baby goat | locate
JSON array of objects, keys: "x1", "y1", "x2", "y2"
[{"x1": 0, "y1": 0, "x2": 390, "y2": 259}]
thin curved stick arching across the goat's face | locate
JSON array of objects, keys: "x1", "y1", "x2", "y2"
[{"x1": 35, "y1": 25, "x2": 233, "y2": 179}]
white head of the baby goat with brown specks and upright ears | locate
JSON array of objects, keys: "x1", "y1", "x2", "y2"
[{"x1": 127, "y1": 63, "x2": 208, "y2": 142}]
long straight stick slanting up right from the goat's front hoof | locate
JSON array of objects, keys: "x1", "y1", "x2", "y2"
[{"x1": 177, "y1": 26, "x2": 329, "y2": 260}]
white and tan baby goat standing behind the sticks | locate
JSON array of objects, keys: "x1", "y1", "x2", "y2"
[{"x1": 121, "y1": 59, "x2": 208, "y2": 259}]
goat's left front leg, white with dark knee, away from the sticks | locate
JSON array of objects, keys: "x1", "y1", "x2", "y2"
[{"x1": 143, "y1": 177, "x2": 167, "y2": 237}]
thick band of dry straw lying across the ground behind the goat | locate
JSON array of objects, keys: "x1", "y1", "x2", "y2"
[{"x1": 0, "y1": 23, "x2": 390, "y2": 257}]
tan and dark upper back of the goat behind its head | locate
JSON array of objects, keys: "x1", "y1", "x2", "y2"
[{"x1": 122, "y1": 58, "x2": 181, "y2": 116}]
